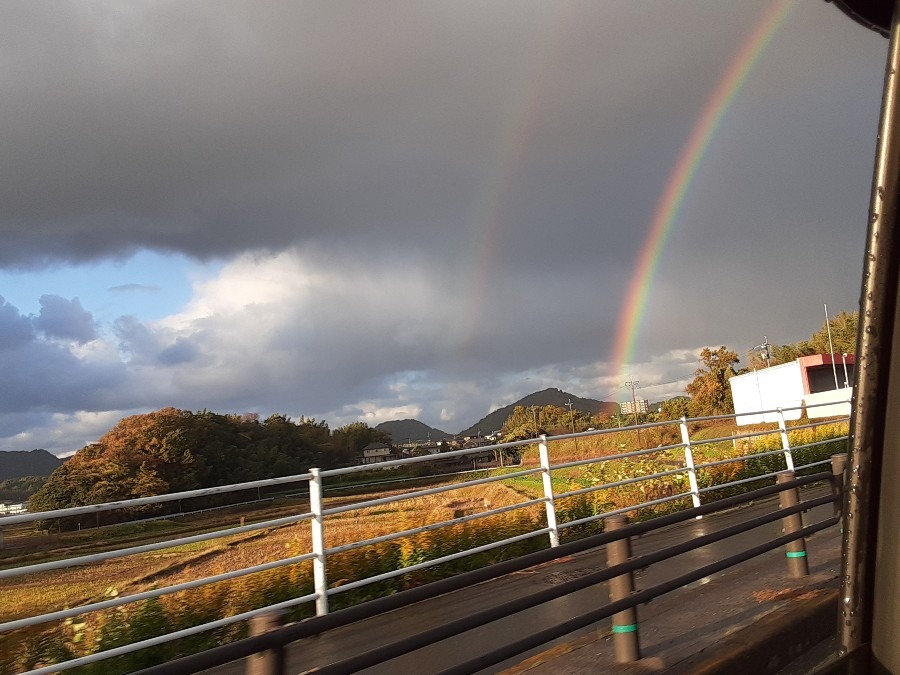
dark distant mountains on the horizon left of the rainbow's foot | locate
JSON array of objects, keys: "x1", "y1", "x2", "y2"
[{"x1": 375, "y1": 388, "x2": 619, "y2": 443}]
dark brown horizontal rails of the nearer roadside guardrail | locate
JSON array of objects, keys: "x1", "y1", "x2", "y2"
[{"x1": 139, "y1": 472, "x2": 841, "y2": 675}]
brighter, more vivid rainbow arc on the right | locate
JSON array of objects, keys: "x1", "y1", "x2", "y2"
[{"x1": 612, "y1": 0, "x2": 794, "y2": 379}]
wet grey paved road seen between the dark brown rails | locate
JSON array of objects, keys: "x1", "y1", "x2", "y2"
[{"x1": 209, "y1": 491, "x2": 836, "y2": 675}]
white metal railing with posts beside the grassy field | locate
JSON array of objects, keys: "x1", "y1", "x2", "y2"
[{"x1": 0, "y1": 409, "x2": 846, "y2": 673}]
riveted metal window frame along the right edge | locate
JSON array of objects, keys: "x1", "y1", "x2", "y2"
[{"x1": 838, "y1": 0, "x2": 900, "y2": 668}]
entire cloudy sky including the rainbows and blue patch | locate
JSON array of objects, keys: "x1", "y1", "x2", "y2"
[{"x1": 0, "y1": 0, "x2": 887, "y2": 455}]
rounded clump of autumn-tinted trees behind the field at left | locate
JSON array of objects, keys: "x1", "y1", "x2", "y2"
[{"x1": 29, "y1": 408, "x2": 386, "y2": 511}]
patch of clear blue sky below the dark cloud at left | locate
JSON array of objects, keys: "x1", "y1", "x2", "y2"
[{"x1": 0, "y1": 251, "x2": 223, "y2": 325}]
